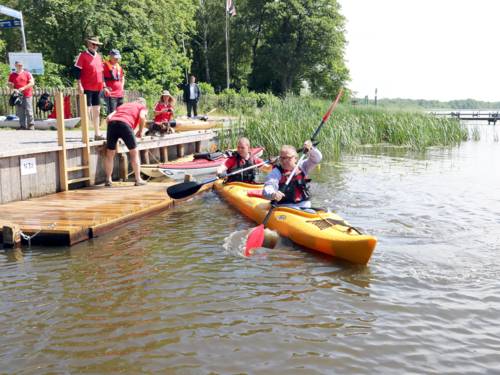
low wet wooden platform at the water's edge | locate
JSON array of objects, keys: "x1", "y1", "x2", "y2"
[{"x1": 0, "y1": 182, "x2": 211, "y2": 245}]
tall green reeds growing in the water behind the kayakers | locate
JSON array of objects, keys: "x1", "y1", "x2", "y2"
[{"x1": 245, "y1": 97, "x2": 469, "y2": 157}]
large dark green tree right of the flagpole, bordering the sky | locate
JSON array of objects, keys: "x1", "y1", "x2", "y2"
[{"x1": 251, "y1": 0, "x2": 349, "y2": 96}]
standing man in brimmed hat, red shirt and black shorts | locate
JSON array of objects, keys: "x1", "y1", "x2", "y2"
[{"x1": 75, "y1": 36, "x2": 105, "y2": 141}]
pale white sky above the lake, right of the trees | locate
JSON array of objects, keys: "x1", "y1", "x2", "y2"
[{"x1": 338, "y1": 0, "x2": 500, "y2": 101}]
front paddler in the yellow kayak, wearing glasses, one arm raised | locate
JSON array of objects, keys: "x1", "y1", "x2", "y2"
[{"x1": 262, "y1": 141, "x2": 323, "y2": 208}]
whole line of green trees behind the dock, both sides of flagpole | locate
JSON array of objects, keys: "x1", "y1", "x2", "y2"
[{"x1": 0, "y1": 0, "x2": 349, "y2": 97}]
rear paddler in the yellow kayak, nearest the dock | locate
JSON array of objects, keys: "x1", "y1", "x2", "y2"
[{"x1": 217, "y1": 137, "x2": 272, "y2": 184}]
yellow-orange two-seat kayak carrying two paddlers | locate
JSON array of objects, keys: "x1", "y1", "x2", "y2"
[{"x1": 214, "y1": 180, "x2": 377, "y2": 264}]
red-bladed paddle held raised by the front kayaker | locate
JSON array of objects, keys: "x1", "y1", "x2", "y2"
[{"x1": 244, "y1": 88, "x2": 343, "y2": 256}]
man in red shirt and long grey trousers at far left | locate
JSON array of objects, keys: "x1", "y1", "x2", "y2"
[{"x1": 8, "y1": 61, "x2": 35, "y2": 130}]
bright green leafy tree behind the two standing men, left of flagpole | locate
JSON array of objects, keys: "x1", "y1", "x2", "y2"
[{"x1": 2, "y1": 0, "x2": 196, "y2": 93}]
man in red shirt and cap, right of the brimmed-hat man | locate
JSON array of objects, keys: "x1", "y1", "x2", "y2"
[{"x1": 103, "y1": 49, "x2": 125, "y2": 115}]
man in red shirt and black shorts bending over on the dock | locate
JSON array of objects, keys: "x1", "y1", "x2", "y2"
[{"x1": 104, "y1": 98, "x2": 148, "y2": 186}]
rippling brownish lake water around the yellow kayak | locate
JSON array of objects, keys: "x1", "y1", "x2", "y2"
[{"x1": 0, "y1": 125, "x2": 500, "y2": 374}]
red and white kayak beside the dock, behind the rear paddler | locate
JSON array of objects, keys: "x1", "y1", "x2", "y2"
[{"x1": 158, "y1": 147, "x2": 264, "y2": 180}]
